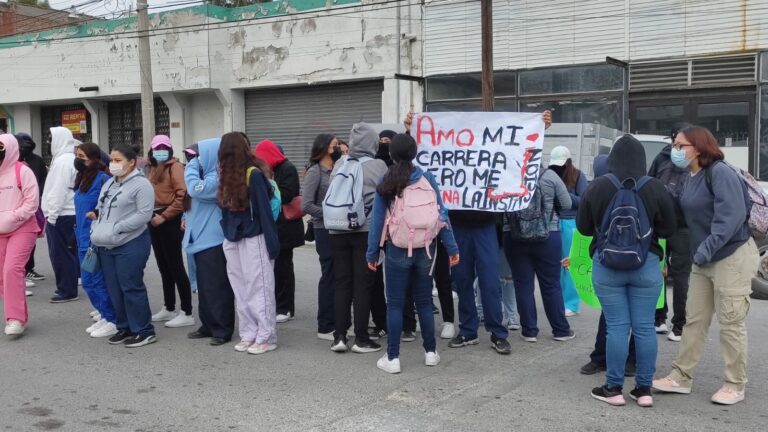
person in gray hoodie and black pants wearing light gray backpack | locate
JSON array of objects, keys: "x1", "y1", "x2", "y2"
[{"x1": 330, "y1": 123, "x2": 387, "y2": 353}]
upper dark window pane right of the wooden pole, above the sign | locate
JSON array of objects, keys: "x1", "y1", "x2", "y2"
[{"x1": 520, "y1": 65, "x2": 624, "y2": 96}]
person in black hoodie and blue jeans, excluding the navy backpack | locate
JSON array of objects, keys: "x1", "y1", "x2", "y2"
[{"x1": 576, "y1": 135, "x2": 677, "y2": 406}]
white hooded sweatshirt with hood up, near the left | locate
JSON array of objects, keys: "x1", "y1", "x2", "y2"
[{"x1": 40, "y1": 126, "x2": 77, "y2": 225}]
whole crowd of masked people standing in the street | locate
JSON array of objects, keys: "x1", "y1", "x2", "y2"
[{"x1": 0, "y1": 112, "x2": 757, "y2": 406}]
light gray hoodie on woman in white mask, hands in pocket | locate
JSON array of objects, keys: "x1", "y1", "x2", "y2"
[{"x1": 91, "y1": 168, "x2": 155, "y2": 249}]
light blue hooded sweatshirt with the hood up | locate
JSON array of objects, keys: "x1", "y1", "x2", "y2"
[{"x1": 182, "y1": 138, "x2": 224, "y2": 254}]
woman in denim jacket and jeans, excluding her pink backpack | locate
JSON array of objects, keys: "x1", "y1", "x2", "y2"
[{"x1": 366, "y1": 134, "x2": 459, "y2": 373}]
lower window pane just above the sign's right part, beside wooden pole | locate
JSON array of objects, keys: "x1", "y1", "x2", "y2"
[{"x1": 520, "y1": 96, "x2": 622, "y2": 130}]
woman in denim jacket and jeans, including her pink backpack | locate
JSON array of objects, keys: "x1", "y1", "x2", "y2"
[{"x1": 366, "y1": 134, "x2": 459, "y2": 373}]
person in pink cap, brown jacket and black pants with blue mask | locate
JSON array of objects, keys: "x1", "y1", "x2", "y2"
[{"x1": 148, "y1": 135, "x2": 195, "y2": 328}]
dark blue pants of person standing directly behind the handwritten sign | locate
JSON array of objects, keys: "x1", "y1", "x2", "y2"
[{"x1": 452, "y1": 225, "x2": 508, "y2": 339}]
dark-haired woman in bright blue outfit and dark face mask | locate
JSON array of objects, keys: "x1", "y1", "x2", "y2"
[{"x1": 75, "y1": 143, "x2": 117, "y2": 338}]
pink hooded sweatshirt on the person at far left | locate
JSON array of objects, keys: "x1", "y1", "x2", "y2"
[{"x1": 0, "y1": 134, "x2": 40, "y2": 237}]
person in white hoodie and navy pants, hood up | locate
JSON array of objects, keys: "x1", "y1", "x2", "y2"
[{"x1": 40, "y1": 126, "x2": 80, "y2": 303}]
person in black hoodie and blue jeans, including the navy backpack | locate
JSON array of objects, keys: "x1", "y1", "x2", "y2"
[{"x1": 576, "y1": 135, "x2": 677, "y2": 406}]
